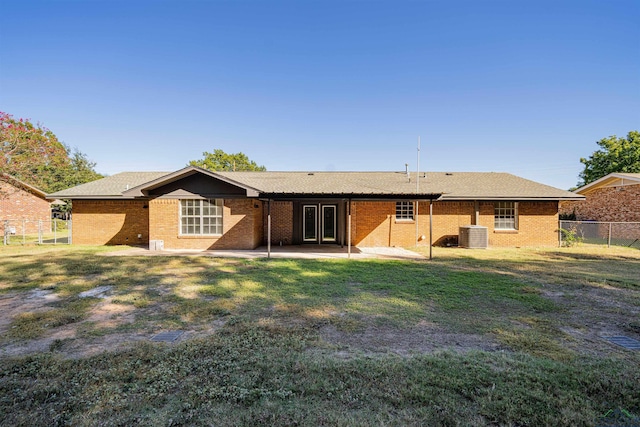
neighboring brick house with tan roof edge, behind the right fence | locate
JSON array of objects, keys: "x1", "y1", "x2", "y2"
[{"x1": 560, "y1": 173, "x2": 640, "y2": 222}]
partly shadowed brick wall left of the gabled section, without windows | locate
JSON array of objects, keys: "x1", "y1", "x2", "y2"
[{"x1": 72, "y1": 200, "x2": 149, "y2": 245}]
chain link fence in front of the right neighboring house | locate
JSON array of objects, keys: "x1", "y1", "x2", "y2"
[{"x1": 558, "y1": 221, "x2": 640, "y2": 249}]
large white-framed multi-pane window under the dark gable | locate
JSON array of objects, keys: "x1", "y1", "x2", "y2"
[{"x1": 180, "y1": 199, "x2": 223, "y2": 236}]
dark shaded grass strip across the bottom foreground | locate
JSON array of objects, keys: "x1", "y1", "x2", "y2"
[{"x1": 0, "y1": 324, "x2": 640, "y2": 426}]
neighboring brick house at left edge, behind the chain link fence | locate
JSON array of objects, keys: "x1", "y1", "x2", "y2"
[{"x1": 0, "y1": 174, "x2": 51, "y2": 234}]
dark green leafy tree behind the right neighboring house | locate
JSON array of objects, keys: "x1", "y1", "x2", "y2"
[{"x1": 578, "y1": 131, "x2": 640, "y2": 187}]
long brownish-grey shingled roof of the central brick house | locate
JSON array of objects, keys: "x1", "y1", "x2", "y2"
[{"x1": 48, "y1": 166, "x2": 583, "y2": 200}]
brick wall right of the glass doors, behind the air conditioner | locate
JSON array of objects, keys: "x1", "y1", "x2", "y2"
[{"x1": 351, "y1": 202, "x2": 558, "y2": 247}]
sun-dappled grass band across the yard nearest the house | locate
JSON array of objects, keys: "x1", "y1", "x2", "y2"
[{"x1": 0, "y1": 249, "x2": 640, "y2": 360}]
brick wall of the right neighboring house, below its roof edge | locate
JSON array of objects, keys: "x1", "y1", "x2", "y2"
[{"x1": 560, "y1": 184, "x2": 640, "y2": 222}]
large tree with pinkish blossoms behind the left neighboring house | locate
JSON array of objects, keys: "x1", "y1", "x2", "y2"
[{"x1": 0, "y1": 112, "x2": 102, "y2": 193}]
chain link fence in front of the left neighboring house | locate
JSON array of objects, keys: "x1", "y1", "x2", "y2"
[{"x1": 0, "y1": 218, "x2": 71, "y2": 245}]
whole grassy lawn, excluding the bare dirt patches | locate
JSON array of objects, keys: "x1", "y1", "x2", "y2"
[{"x1": 0, "y1": 246, "x2": 640, "y2": 426}]
